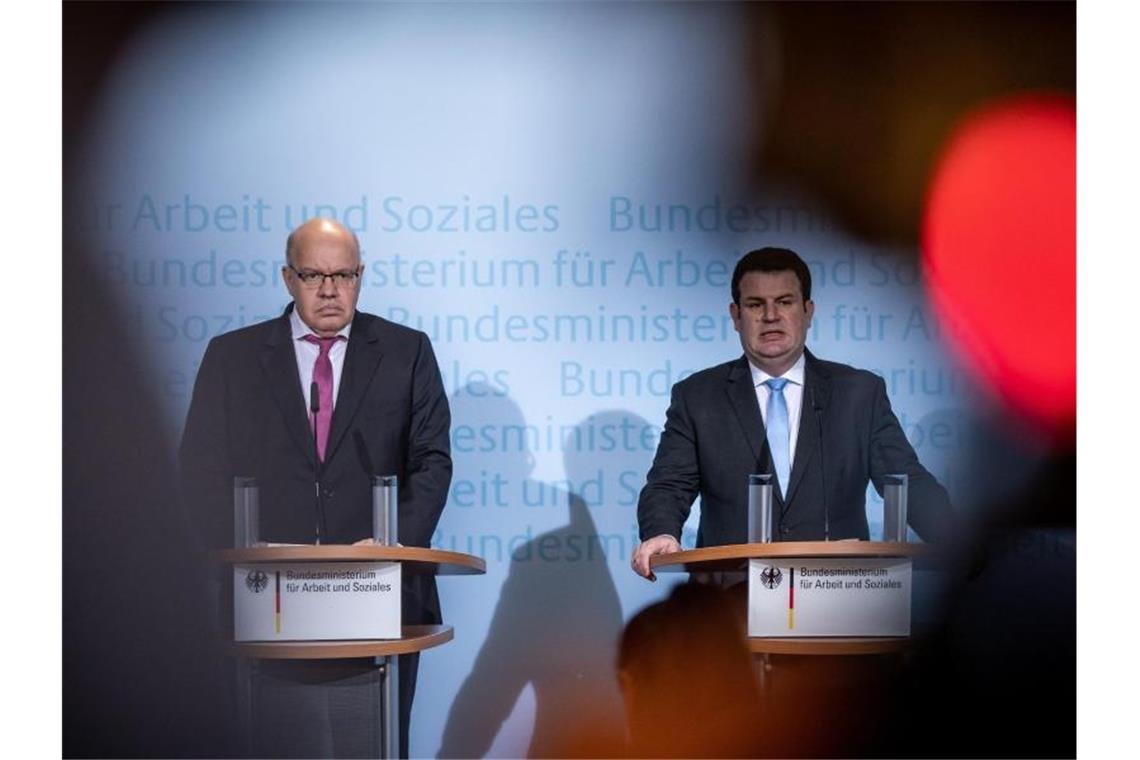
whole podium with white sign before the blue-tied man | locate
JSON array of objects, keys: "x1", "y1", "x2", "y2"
[{"x1": 650, "y1": 541, "x2": 935, "y2": 757}]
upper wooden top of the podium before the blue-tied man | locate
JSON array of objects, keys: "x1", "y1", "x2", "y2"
[{"x1": 649, "y1": 541, "x2": 929, "y2": 573}]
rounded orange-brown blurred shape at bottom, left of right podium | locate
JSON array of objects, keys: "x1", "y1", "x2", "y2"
[{"x1": 618, "y1": 583, "x2": 763, "y2": 758}]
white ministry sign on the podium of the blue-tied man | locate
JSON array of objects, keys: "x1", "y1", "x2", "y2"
[{"x1": 748, "y1": 557, "x2": 911, "y2": 637}]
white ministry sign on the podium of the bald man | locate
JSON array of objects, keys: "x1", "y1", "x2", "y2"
[{"x1": 234, "y1": 562, "x2": 400, "y2": 641}]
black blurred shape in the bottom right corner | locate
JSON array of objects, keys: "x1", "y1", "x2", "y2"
[{"x1": 871, "y1": 452, "x2": 1077, "y2": 758}]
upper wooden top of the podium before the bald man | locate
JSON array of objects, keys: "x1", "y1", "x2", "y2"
[{"x1": 214, "y1": 544, "x2": 487, "y2": 575}]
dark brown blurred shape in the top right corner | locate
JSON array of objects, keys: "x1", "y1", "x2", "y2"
[{"x1": 754, "y1": 2, "x2": 1076, "y2": 245}]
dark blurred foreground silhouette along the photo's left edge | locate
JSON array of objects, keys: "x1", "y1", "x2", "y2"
[{"x1": 62, "y1": 2, "x2": 234, "y2": 758}]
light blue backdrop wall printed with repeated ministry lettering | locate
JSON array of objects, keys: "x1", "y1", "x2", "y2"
[{"x1": 68, "y1": 5, "x2": 1016, "y2": 755}]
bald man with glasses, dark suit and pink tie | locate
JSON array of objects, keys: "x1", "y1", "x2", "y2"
[{"x1": 181, "y1": 219, "x2": 451, "y2": 757}]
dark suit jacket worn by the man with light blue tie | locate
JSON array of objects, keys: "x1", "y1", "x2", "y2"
[{"x1": 637, "y1": 352, "x2": 951, "y2": 547}]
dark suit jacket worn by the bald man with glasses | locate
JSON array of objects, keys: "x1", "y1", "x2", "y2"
[{"x1": 181, "y1": 307, "x2": 451, "y2": 624}]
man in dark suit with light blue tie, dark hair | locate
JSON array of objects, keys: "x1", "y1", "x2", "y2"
[{"x1": 632, "y1": 248, "x2": 951, "y2": 580}]
